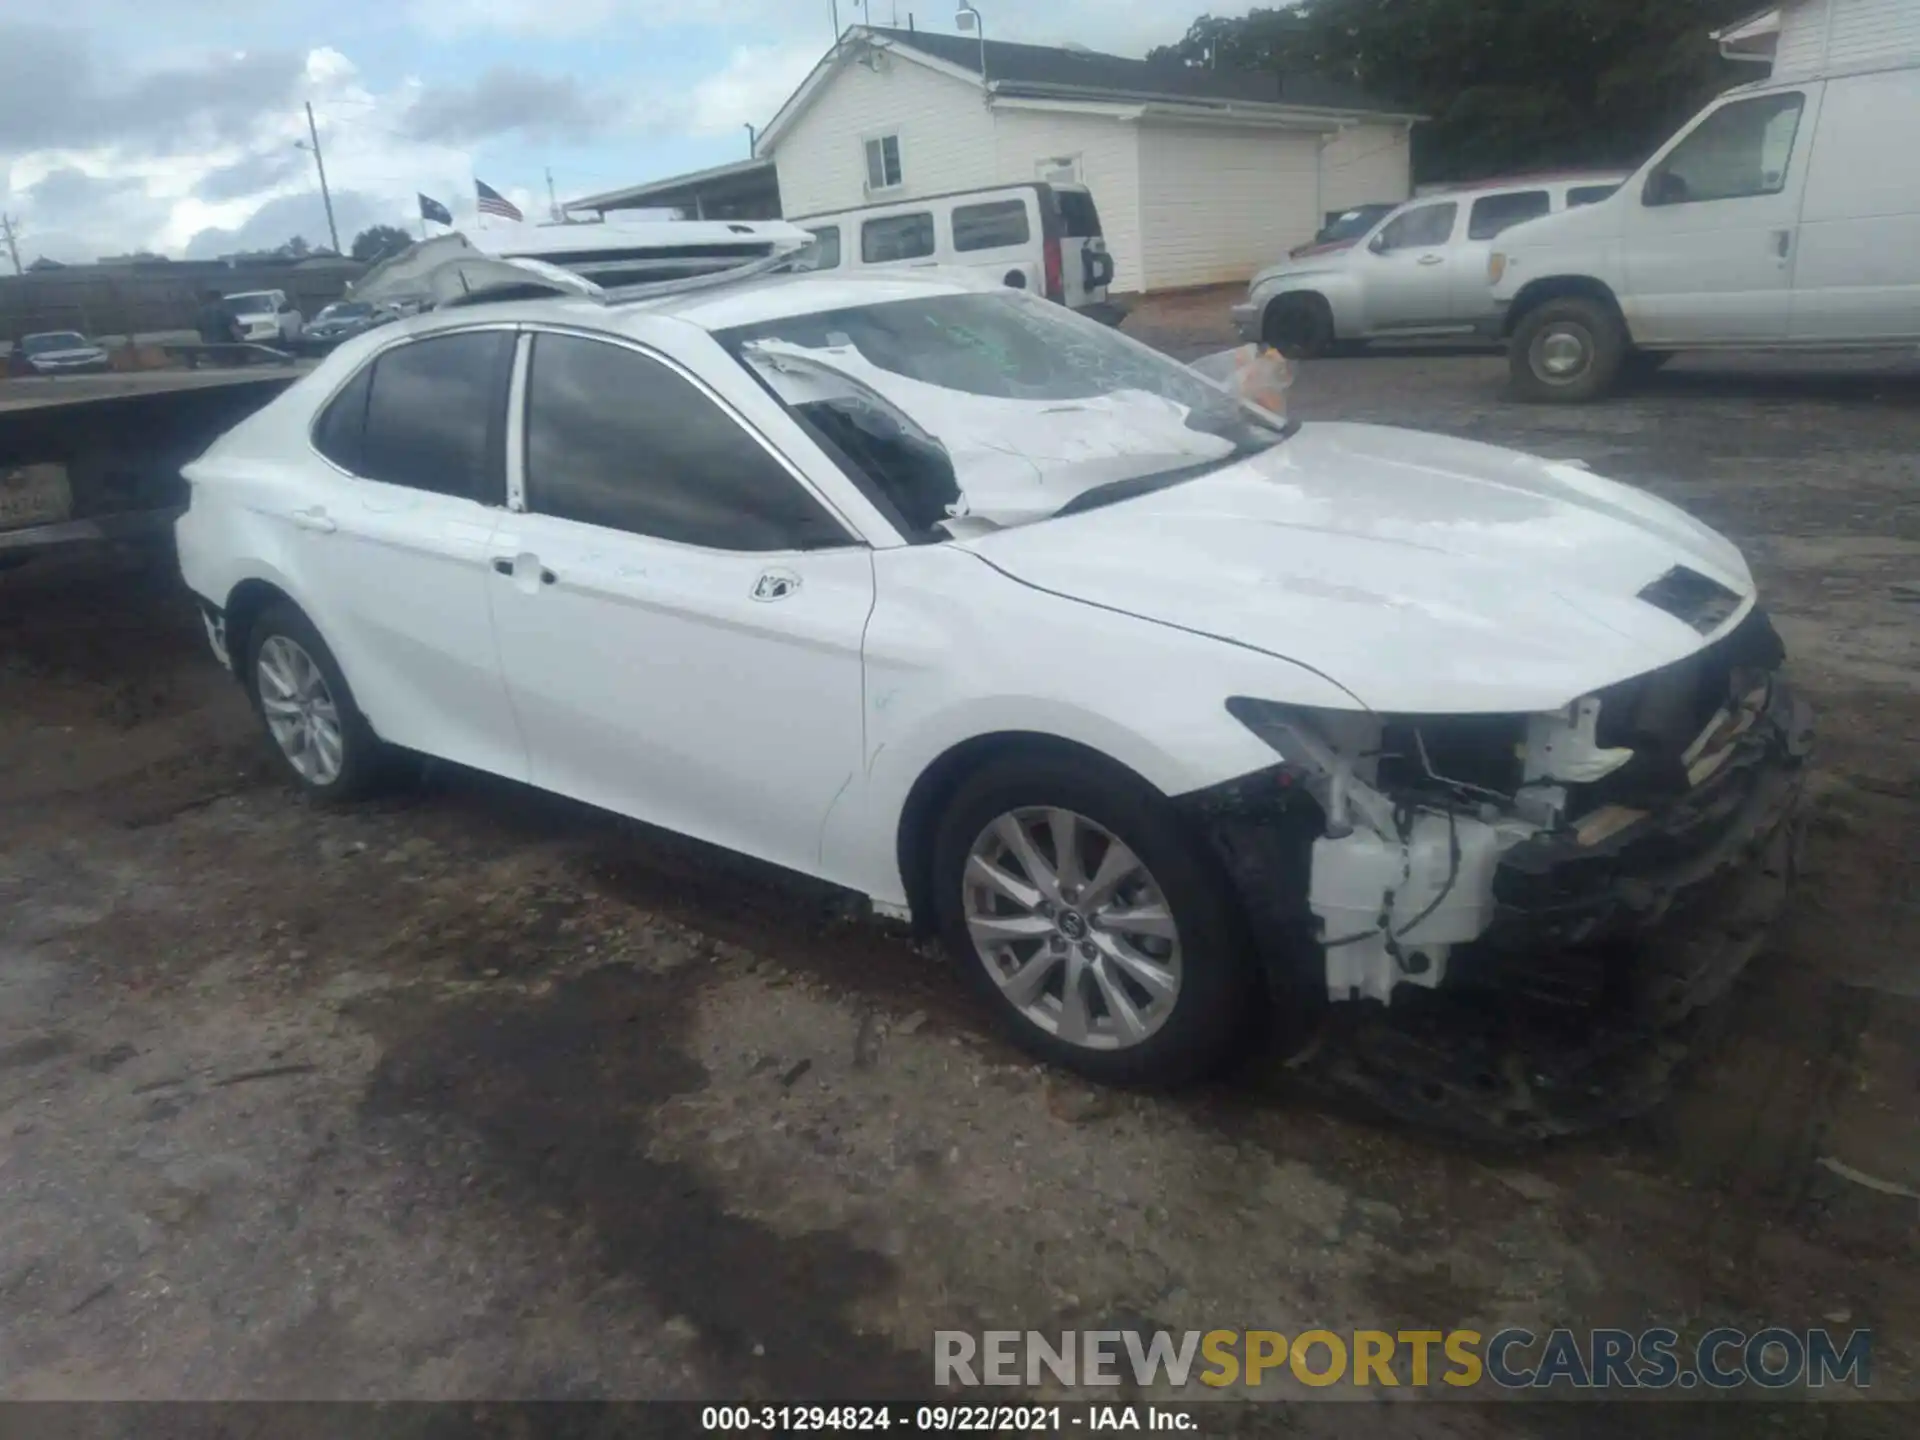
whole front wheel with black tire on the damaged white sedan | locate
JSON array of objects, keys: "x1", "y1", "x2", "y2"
[{"x1": 933, "y1": 755, "x2": 1260, "y2": 1085}]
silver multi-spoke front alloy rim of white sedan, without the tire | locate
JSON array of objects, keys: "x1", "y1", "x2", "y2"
[{"x1": 962, "y1": 808, "x2": 1181, "y2": 1050}]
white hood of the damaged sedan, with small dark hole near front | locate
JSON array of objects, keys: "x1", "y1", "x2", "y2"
[{"x1": 966, "y1": 424, "x2": 1753, "y2": 712}]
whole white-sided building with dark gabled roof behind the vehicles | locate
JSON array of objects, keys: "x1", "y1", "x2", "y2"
[{"x1": 755, "y1": 27, "x2": 1419, "y2": 290}]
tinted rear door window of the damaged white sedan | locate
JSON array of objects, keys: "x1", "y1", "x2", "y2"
[{"x1": 359, "y1": 330, "x2": 513, "y2": 505}]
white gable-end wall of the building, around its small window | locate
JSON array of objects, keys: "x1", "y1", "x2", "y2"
[{"x1": 774, "y1": 54, "x2": 998, "y2": 217}]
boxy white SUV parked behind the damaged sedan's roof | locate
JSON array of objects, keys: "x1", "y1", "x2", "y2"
[{"x1": 793, "y1": 180, "x2": 1125, "y2": 324}]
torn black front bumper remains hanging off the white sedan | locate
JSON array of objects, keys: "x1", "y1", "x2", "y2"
[{"x1": 1300, "y1": 682, "x2": 1812, "y2": 1142}]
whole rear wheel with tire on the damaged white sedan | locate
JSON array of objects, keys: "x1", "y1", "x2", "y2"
[{"x1": 246, "y1": 603, "x2": 388, "y2": 803}]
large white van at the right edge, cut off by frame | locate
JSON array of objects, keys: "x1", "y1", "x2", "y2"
[{"x1": 1488, "y1": 60, "x2": 1920, "y2": 401}]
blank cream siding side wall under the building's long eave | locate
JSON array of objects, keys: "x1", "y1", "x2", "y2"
[{"x1": 1140, "y1": 123, "x2": 1319, "y2": 290}]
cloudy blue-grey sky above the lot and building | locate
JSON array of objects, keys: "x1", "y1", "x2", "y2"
[{"x1": 0, "y1": 0, "x2": 1248, "y2": 261}]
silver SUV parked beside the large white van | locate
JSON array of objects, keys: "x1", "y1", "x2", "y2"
[{"x1": 1233, "y1": 173, "x2": 1624, "y2": 357}]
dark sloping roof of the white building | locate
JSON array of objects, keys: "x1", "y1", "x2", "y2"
[{"x1": 870, "y1": 25, "x2": 1407, "y2": 115}]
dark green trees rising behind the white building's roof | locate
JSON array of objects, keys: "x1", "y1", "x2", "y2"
[{"x1": 1148, "y1": 0, "x2": 1753, "y2": 180}]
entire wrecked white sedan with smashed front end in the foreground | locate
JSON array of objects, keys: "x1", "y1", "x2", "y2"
[{"x1": 179, "y1": 264, "x2": 1809, "y2": 1131}]
